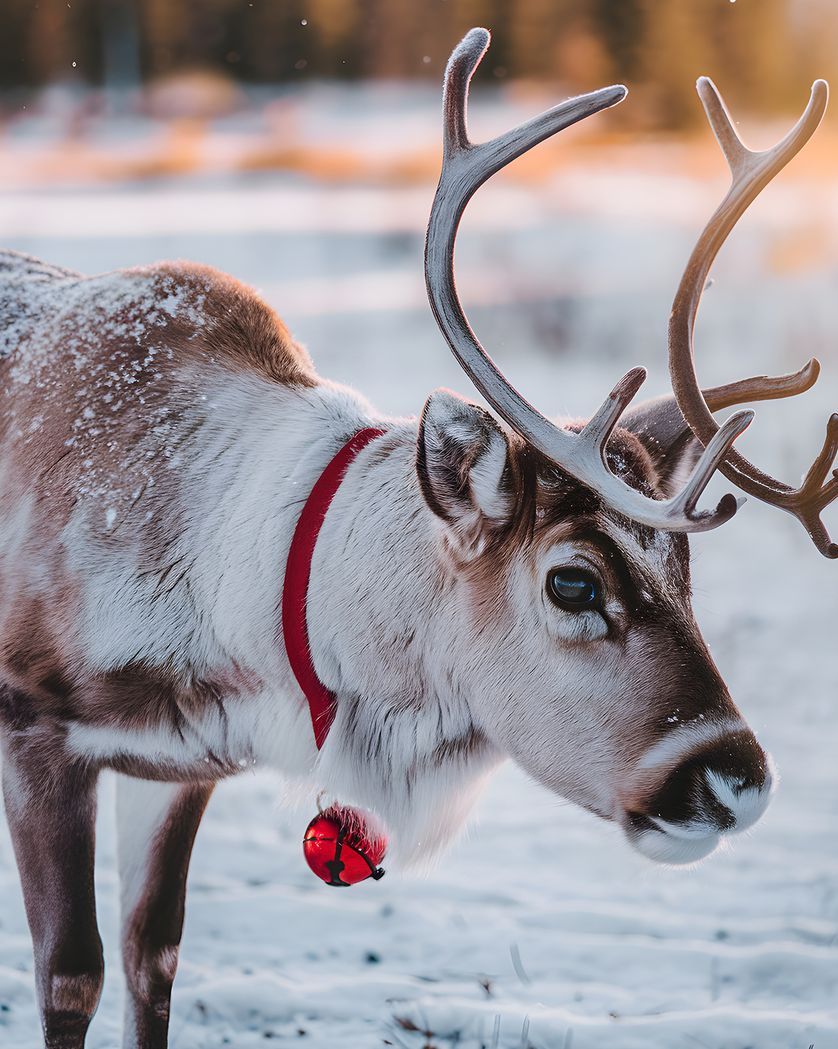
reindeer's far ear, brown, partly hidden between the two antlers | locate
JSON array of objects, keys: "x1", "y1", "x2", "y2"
[{"x1": 620, "y1": 393, "x2": 704, "y2": 498}]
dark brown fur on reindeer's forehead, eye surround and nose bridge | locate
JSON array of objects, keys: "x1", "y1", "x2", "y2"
[{"x1": 458, "y1": 429, "x2": 736, "y2": 768}]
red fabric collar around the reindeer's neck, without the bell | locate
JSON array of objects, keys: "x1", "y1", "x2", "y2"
[{"x1": 282, "y1": 427, "x2": 385, "y2": 750}]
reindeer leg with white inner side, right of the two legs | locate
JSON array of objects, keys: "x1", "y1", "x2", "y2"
[{"x1": 116, "y1": 776, "x2": 213, "y2": 1049}]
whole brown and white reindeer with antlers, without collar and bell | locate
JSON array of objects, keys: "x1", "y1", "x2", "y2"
[{"x1": 0, "y1": 29, "x2": 838, "y2": 1049}]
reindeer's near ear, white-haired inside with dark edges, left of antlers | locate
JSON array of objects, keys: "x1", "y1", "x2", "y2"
[{"x1": 416, "y1": 390, "x2": 514, "y2": 555}]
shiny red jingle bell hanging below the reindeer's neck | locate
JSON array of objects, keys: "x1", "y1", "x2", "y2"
[{"x1": 303, "y1": 805, "x2": 387, "y2": 885}]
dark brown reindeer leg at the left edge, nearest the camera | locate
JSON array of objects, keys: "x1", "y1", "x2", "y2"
[{"x1": 2, "y1": 730, "x2": 104, "y2": 1049}]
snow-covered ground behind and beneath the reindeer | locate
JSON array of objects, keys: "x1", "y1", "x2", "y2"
[{"x1": 0, "y1": 141, "x2": 838, "y2": 1049}]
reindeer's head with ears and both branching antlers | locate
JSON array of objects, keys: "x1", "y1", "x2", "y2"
[{"x1": 404, "y1": 29, "x2": 838, "y2": 862}]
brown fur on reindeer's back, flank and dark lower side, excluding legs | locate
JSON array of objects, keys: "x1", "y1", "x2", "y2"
[{"x1": 0, "y1": 252, "x2": 310, "y2": 728}]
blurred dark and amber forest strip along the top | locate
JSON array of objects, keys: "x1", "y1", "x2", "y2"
[{"x1": 0, "y1": 0, "x2": 838, "y2": 127}]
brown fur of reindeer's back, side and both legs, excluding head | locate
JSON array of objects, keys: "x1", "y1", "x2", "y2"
[{"x1": 0, "y1": 252, "x2": 318, "y2": 1049}]
